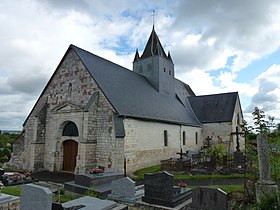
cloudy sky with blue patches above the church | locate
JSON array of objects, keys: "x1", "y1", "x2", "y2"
[{"x1": 0, "y1": 0, "x2": 280, "y2": 130}]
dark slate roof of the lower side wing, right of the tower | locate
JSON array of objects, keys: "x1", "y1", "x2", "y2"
[{"x1": 188, "y1": 92, "x2": 238, "y2": 123}]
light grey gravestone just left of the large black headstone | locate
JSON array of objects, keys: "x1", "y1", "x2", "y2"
[{"x1": 108, "y1": 177, "x2": 144, "y2": 204}]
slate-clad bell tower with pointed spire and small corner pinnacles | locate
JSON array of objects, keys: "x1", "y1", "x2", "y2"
[{"x1": 133, "y1": 27, "x2": 175, "y2": 96}]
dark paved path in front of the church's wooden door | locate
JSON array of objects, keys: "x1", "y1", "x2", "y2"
[{"x1": 32, "y1": 171, "x2": 75, "y2": 184}]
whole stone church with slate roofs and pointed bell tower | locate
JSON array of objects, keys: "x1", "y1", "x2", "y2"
[{"x1": 11, "y1": 28, "x2": 243, "y2": 173}]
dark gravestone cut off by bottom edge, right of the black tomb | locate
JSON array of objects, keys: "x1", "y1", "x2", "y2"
[{"x1": 192, "y1": 187, "x2": 228, "y2": 210}]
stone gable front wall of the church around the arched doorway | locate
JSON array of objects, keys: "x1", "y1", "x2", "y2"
[{"x1": 13, "y1": 50, "x2": 114, "y2": 172}]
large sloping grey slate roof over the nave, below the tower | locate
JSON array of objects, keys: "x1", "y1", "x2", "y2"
[{"x1": 69, "y1": 45, "x2": 201, "y2": 127}]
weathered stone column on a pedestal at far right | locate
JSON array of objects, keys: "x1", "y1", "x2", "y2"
[{"x1": 256, "y1": 134, "x2": 278, "y2": 202}]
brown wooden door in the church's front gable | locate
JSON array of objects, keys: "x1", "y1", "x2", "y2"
[{"x1": 63, "y1": 140, "x2": 78, "y2": 172}]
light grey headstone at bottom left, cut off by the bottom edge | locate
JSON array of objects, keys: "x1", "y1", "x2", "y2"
[{"x1": 20, "y1": 184, "x2": 52, "y2": 210}]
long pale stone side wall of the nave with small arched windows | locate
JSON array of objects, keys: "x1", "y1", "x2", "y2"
[{"x1": 124, "y1": 118, "x2": 203, "y2": 173}]
